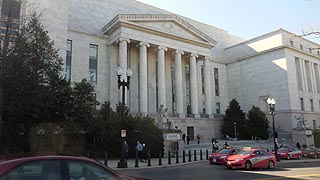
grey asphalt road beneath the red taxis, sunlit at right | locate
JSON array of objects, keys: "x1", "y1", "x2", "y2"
[{"x1": 121, "y1": 162, "x2": 320, "y2": 180}]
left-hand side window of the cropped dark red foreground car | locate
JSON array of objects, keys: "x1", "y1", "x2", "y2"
[{"x1": 0, "y1": 160, "x2": 61, "y2": 180}]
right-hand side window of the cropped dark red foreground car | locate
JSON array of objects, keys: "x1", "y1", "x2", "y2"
[{"x1": 67, "y1": 161, "x2": 118, "y2": 180}]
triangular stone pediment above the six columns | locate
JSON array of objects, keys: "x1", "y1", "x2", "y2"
[{"x1": 102, "y1": 14, "x2": 216, "y2": 47}]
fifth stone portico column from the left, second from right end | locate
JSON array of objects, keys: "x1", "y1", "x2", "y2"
[{"x1": 190, "y1": 54, "x2": 199, "y2": 115}]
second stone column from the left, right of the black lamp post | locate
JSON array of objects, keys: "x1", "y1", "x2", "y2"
[{"x1": 139, "y1": 42, "x2": 150, "y2": 113}]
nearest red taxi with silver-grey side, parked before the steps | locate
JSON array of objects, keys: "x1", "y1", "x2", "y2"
[{"x1": 226, "y1": 149, "x2": 277, "y2": 170}]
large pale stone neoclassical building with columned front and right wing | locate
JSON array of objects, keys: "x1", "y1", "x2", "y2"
[{"x1": 0, "y1": 0, "x2": 320, "y2": 139}]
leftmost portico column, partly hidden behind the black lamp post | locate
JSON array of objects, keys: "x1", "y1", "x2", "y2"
[{"x1": 119, "y1": 38, "x2": 130, "y2": 104}]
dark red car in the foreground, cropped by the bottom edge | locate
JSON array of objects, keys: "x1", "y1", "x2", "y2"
[{"x1": 0, "y1": 155, "x2": 148, "y2": 180}]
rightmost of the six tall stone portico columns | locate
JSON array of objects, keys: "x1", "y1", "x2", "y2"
[{"x1": 203, "y1": 57, "x2": 212, "y2": 115}]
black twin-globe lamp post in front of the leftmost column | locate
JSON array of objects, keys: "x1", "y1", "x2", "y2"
[{"x1": 116, "y1": 66, "x2": 132, "y2": 168}]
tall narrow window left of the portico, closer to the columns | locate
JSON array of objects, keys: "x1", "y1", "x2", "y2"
[{"x1": 89, "y1": 44, "x2": 98, "y2": 84}]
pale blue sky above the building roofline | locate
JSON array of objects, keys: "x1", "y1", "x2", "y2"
[{"x1": 137, "y1": 0, "x2": 320, "y2": 43}]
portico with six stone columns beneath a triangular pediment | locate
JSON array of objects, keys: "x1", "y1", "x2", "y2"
[{"x1": 102, "y1": 14, "x2": 216, "y2": 118}]
